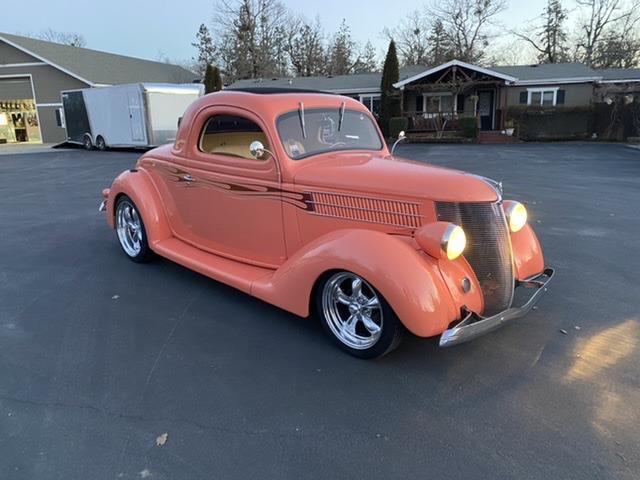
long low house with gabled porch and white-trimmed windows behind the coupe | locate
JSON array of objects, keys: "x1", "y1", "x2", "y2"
[{"x1": 229, "y1": 60, "x2": 640, "y2": 139}]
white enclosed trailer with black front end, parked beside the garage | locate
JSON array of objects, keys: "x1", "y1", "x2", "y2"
[{"x1": 62, "y1": 83, "x2": 204, "y2": 150}]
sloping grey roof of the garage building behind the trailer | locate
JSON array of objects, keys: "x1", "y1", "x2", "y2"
[{"x1": 0, "y1": 32, "x2": 196, "y2": 85}]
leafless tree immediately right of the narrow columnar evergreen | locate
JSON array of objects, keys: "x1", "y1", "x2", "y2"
[{"x1": 382, "y1": 10, "x2": 429, "y2": 65}]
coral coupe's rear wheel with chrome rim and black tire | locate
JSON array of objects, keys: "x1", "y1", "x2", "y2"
[{"x1": 115, "y1": 195, "x2": 153, "y2": 263}]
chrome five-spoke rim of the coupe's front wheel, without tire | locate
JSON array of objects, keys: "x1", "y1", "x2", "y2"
[{"x1": 322, "y1": 272, "x2": 383, "y2": 350}]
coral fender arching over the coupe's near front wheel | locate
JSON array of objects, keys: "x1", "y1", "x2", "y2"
[{"x1": 251, "y1": 229, "x2": 476, "y2": 337}]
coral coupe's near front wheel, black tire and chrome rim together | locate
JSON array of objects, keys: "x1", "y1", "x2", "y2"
[{"x1": 315, "y1": 271, "x2": 404, "y2": 358}]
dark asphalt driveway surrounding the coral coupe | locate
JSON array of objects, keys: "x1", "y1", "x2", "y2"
[{"x1": 0, "y1": 144, "x2": 640, "y2": 480}]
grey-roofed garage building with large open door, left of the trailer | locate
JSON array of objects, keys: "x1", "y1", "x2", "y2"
[{"x1": 0, "y1": 32, "x2": 196, "y2": 143}]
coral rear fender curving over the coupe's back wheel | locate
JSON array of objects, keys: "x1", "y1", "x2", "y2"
[{"x1": 106, "y1": 169, "x2": 172, "y2": 249}]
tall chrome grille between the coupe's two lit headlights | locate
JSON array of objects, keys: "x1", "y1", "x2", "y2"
[{"x1": 436, "y1": 202, "x2": 514, "y2": 316}]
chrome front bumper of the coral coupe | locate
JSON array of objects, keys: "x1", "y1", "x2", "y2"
[{"x1": 440, "y1": 268, "x2": 554, "y2": 347}]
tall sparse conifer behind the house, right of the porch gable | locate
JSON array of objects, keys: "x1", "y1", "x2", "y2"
[{"x1": 512, "y1": 0, "x2": 568, "y2": 63}]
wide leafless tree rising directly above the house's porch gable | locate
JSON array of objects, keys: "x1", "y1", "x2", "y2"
[{"x1": 429, "y1": 0, "x2": 506, "y2": 62}]
